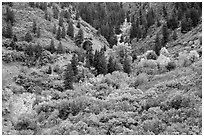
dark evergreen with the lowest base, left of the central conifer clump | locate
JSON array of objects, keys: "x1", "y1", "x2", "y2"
[{"x1": 64, "y1": 64, "x2": 74, "y2": 90}]
